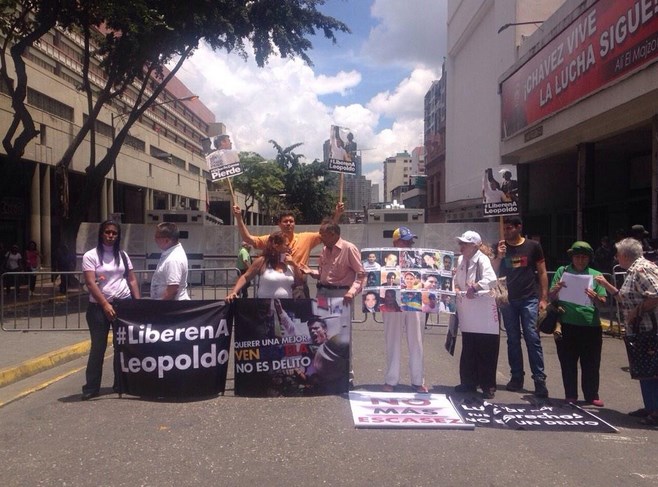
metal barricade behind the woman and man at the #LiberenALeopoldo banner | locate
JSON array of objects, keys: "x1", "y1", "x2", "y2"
[{"x1": 0, "y1": 267, "x2": 237, "y2": 331}]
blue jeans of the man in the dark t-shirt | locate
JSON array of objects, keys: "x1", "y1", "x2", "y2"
[{"x1": 501, "y1": 298, "x2": 546, "y2": 381}]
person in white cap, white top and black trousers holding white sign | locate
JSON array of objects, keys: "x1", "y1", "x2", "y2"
[{"x1": 453, "y1": 230, "x2": 500, "y2": 399}]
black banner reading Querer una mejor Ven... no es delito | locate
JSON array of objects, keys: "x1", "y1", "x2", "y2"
[{"x1": 234, "y1": 298, "x2": 351, "y2": 397}]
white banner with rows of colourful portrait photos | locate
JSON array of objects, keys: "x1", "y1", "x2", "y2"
[{"x1": 361, "y1": 247, "x2": 456, "y2": 313}]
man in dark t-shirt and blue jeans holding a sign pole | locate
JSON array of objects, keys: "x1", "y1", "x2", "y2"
[{"x1": 493, "y1": 217, "x2": 548, "y2": 398}]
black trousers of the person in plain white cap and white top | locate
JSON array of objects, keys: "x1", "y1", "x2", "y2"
[{"x1": 459, "y1": 332, "x2": 500, "y2": 391}]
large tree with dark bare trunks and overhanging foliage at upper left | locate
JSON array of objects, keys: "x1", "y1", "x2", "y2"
[{"x1": 0, "y1": 0, "x2": 349, "y2": 245}]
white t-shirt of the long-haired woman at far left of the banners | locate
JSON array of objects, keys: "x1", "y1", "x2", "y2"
[{"x1": 82, "y1": 245, "x2": 133, "y2": 303}]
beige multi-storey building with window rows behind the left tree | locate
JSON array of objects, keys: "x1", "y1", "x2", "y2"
[{"x1": 0, "y1": 25, "x2": 219, "y2": 263}]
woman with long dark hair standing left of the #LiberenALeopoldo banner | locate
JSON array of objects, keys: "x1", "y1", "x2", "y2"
[{"x1": 81, "y1": 220, "x2": 140, "y2": 401}]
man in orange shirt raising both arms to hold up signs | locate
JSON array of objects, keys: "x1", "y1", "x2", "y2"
[{"x1": 233, "y1": 202, "x2": 345, "y2": 298}]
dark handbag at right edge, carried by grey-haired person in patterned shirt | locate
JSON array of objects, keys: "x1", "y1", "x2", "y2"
[{"x1": 624, "y1": 312, "x2": 658, "y2": 380}]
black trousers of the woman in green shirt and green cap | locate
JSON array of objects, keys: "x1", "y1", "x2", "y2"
[{"x1": 555, "y1": 323, "x2": 603, "y2": 402}]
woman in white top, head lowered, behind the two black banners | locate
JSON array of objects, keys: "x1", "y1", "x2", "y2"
[{"x1": 226, "y1": 232, "x2": 303, "y2": 303}]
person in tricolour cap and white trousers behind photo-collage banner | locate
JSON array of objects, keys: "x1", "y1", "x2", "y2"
[{"x1": 382, "y1": 227, "x2": 428, "y2": 393}]
